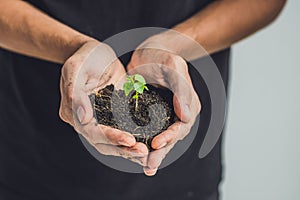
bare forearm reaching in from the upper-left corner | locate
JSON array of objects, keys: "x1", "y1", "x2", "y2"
[{"x1": 0, "y1": 0, "x2": 92, "y2": 63}]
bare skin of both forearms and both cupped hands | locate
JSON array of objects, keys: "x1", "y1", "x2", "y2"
[{"x1": 0, "y1": 0, "x2": 286, "y2": 176}]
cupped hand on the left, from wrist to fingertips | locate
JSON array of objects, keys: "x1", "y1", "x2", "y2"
[{"x1": 59, "y1": 41, "x2": 148, "y2": 166}]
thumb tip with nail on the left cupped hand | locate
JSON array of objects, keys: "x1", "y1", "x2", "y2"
[{"x1": 73, "y1": 93, "x2": 93, "y2": 125}]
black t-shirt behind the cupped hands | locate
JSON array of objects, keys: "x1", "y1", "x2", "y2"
[{"x1": 0, "y1": 0, "x2": 229, "y2": 200}]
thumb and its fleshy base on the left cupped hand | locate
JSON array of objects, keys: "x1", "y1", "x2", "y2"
[{"x1": 62, "y1": 43, "x2": 119, "y2": 124}]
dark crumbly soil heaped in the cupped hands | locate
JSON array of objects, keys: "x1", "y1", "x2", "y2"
[{"x1": 90, "y1": 85, "x2": 177, "y2": 150}]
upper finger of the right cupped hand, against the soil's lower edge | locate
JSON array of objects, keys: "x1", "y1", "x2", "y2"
[{"x1": 151, "y1": 121, "x2": 184, "y2": 149}]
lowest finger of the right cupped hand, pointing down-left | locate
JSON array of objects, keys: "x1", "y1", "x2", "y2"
[{"x1": 143, "y1": 143, "x2": 175, "y2": 176}]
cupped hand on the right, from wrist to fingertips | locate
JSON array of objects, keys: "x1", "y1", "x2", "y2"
[{"x1": 127, "y1": 41, "x2": 201, "y2": 176}]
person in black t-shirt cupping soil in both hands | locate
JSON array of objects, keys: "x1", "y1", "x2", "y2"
[{"x1": 0, "y1": 0, "x2": 285, "y2": 200}]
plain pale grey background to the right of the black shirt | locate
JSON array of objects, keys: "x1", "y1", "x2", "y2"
[{"x1": 221, "y1": 0, "x2": 300, "y2": 200}]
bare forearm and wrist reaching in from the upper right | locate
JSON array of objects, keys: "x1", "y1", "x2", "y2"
[{"x1": 150, "y1": 0, "x2": 285, "y2": 60}]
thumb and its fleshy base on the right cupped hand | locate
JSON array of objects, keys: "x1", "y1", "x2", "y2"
[{"x1": 127, "y1": 49, "x2": 194, "y2": 123}]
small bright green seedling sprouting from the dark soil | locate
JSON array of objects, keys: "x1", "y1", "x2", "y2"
[{"x1": 123, "y1": 74, "x2": 149, "y2": 109}]
